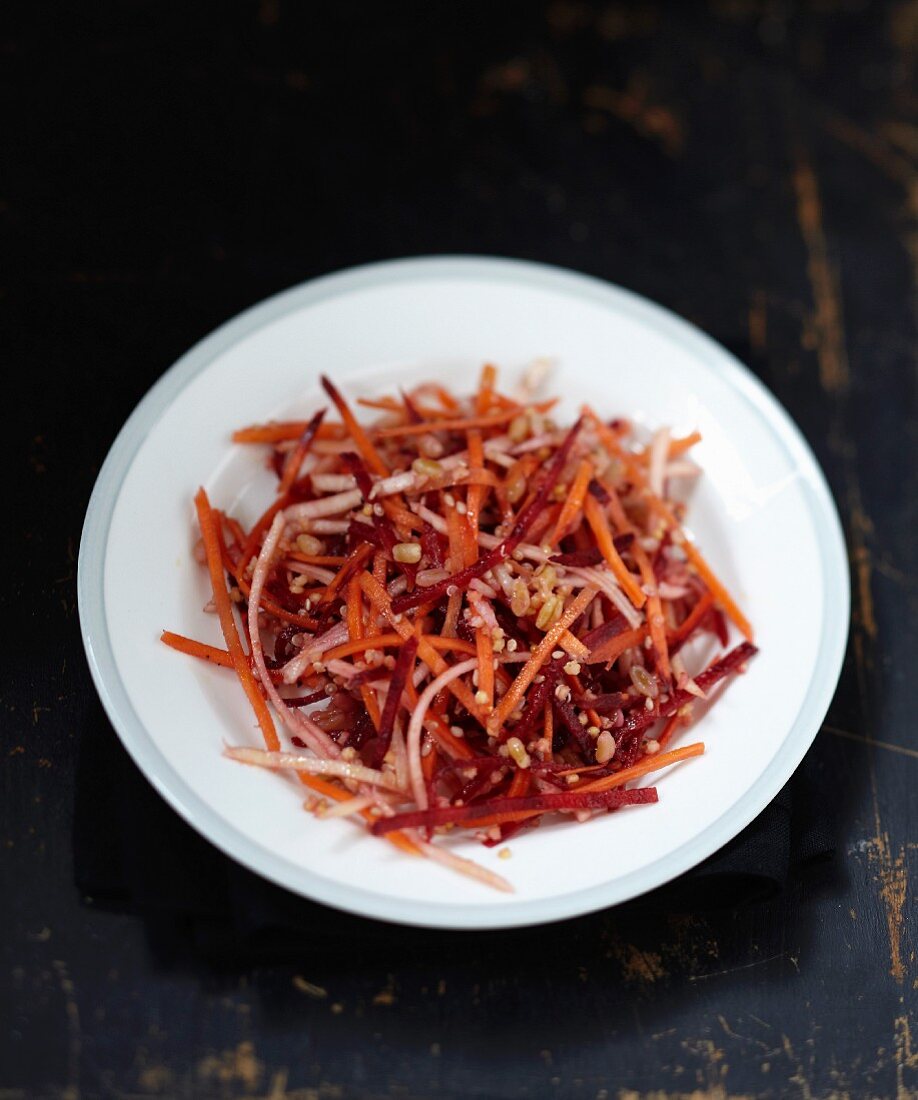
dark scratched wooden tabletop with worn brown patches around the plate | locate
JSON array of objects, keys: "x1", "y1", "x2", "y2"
[{"x1": 0, "y1": 0, "x2": 918, "y2": 1100}]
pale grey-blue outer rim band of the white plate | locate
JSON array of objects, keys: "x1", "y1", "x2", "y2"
[{"x1": 77, "y1": 255, "x2": 851, "y2": 931}]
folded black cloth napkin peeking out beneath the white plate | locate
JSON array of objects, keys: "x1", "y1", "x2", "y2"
[{"x1": 74, "y1": 708, "x2": 834, "y2": 963}]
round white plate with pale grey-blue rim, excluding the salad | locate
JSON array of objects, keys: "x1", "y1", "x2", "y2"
[{"x1": 79, "y1": 257, "x2": 849, "y2": 928}]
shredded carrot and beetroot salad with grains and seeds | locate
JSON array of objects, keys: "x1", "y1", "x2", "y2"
[{"x1": 163, "y1": 366, "x2": 756, "y2": 890}]
